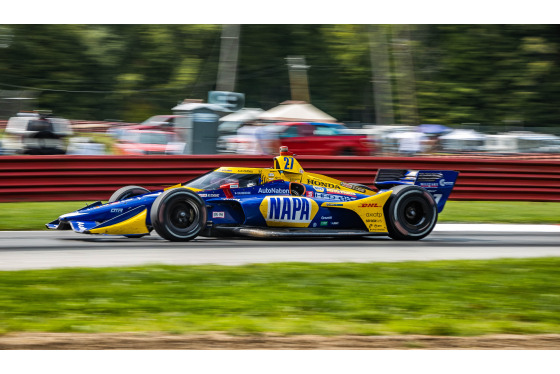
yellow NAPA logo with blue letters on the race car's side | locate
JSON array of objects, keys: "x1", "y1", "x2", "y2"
[{"x1": 260, "y1": 196, "x2": 319, "y2": 227}]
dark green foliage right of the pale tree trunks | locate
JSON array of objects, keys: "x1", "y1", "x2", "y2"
[{"x1": 413, "y1": 25, "x2": 560, "y2": 126}]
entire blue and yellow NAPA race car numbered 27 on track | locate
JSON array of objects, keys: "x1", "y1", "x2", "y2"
[{"x1": 46, "y1": 147, "x2": 459, "y2": 241}]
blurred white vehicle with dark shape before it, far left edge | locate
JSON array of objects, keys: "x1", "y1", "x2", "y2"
[{"x1": 4, "y1": 112, "x2": 73, "y2": 155}]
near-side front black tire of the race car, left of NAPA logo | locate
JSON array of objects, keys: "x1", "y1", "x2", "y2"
[{"x1": 150, "y1": 188, "x2": 207, "y2": 242}]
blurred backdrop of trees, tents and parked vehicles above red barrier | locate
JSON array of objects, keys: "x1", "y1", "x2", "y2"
[{"x1": 0, "y1": 24, "x2": 560, "y2": 157}]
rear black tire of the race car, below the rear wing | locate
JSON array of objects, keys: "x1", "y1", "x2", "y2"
[{"x1": 383, "y1": 185, "x2": 438, "y2": 240}]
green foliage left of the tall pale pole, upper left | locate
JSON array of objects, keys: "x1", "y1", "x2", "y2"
[{"x1": 0, "y1": 25, "x2": 220, "y2": 121}]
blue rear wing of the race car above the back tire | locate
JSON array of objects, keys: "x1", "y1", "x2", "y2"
[{"x1": 373, "y1": 169, "x2": 459, "y2": 213}]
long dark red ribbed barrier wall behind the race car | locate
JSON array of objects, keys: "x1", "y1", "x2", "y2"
[{"x1": 0, "y1": 155, "x2": 560, "y2": 202}]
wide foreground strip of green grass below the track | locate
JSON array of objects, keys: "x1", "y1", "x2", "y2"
[{"x1": 0, "y1": 258, "x2": 560, "y2": 336}]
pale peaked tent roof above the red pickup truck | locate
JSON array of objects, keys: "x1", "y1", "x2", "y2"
[{"x1": 258, "y1": 101, "x2": 336, "y2": 122}]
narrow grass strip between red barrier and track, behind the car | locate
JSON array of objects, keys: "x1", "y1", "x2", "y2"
[{"x1": 0, "y1": 201, "x2": 560, "y2": 230}]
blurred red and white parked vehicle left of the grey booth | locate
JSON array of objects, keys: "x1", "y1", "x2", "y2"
[{"x1": 115, "y1": 130, "x2": 185, "y2": 155}]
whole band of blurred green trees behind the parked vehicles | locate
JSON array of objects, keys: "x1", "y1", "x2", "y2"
[{"x1": 0, "y1": 24, "x2": 560, "y2": 127}]
